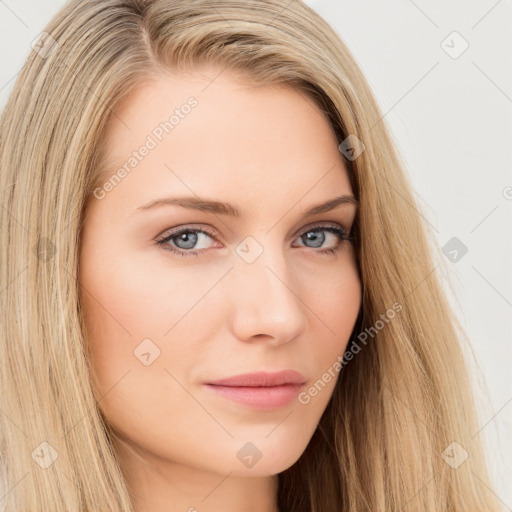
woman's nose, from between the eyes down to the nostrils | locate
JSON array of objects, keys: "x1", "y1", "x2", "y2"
[{"x1": 227, "y1": 245, "x2": 308, "y2": 345}]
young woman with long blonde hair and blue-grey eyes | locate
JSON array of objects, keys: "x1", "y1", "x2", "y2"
[{"x1": 0, "y1": 0, "x2": 498, "y2": 512}]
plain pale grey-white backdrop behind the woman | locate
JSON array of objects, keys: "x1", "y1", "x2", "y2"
[{"x1": 0, "y1": 0, "x2": 512, "y2": 510}]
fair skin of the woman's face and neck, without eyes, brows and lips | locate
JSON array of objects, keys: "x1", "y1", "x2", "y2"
[{"x1": 79, "y1": 67, "x2": 361, "y2": 512}]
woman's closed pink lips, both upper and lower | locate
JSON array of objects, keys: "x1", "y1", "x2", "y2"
[{"x1": 205, "y1": 370, "x2": 306, "y2": 410}]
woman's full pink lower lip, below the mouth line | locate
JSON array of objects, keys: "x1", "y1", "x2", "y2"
[{"x1": 205, "y1": 384, "x2": 302, "y2": 410}]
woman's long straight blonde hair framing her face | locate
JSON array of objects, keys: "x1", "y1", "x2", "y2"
[{"x1": 0, "y1": 0, "x2": 498, "y2": 512}]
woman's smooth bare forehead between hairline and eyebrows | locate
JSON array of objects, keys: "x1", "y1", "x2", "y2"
[{"x1": 96, "y1": 70, "x2": 351, "y2": 212}]
